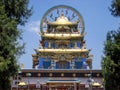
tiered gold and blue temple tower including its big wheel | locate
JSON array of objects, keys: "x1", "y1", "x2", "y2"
[{"x1": 32, "y1": 5, "x2": 92, "y2": 70}]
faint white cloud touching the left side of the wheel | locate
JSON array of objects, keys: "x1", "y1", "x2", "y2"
[{"x1": 26, "y1": 21, "x2": 40, "y2": 34}]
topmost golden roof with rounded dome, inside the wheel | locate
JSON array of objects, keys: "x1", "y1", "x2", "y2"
[{"x1": 48, "y1": 15, "x2": 77, "y2": 25}]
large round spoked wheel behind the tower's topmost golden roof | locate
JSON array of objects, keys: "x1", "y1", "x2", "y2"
[{"x1": 40, "y1": 5, "x2": 84, "y2": 34}]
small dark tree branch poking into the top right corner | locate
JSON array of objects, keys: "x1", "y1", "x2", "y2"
[{"x1": 110, "y1": 0, "x2": 120, "y2": 16}]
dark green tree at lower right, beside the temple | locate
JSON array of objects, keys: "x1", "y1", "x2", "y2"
[{"x1": 102, "y1": 28, "x2": 120, "y2": 90}]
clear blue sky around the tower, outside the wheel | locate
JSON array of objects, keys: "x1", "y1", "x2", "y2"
[{"x1": 19, "y1": 0, "x2": 120, "y2": 69}]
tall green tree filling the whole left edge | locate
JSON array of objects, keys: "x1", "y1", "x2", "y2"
[{"x1": 0, "y1": 0, "x2": 32, "y2": 90}]
